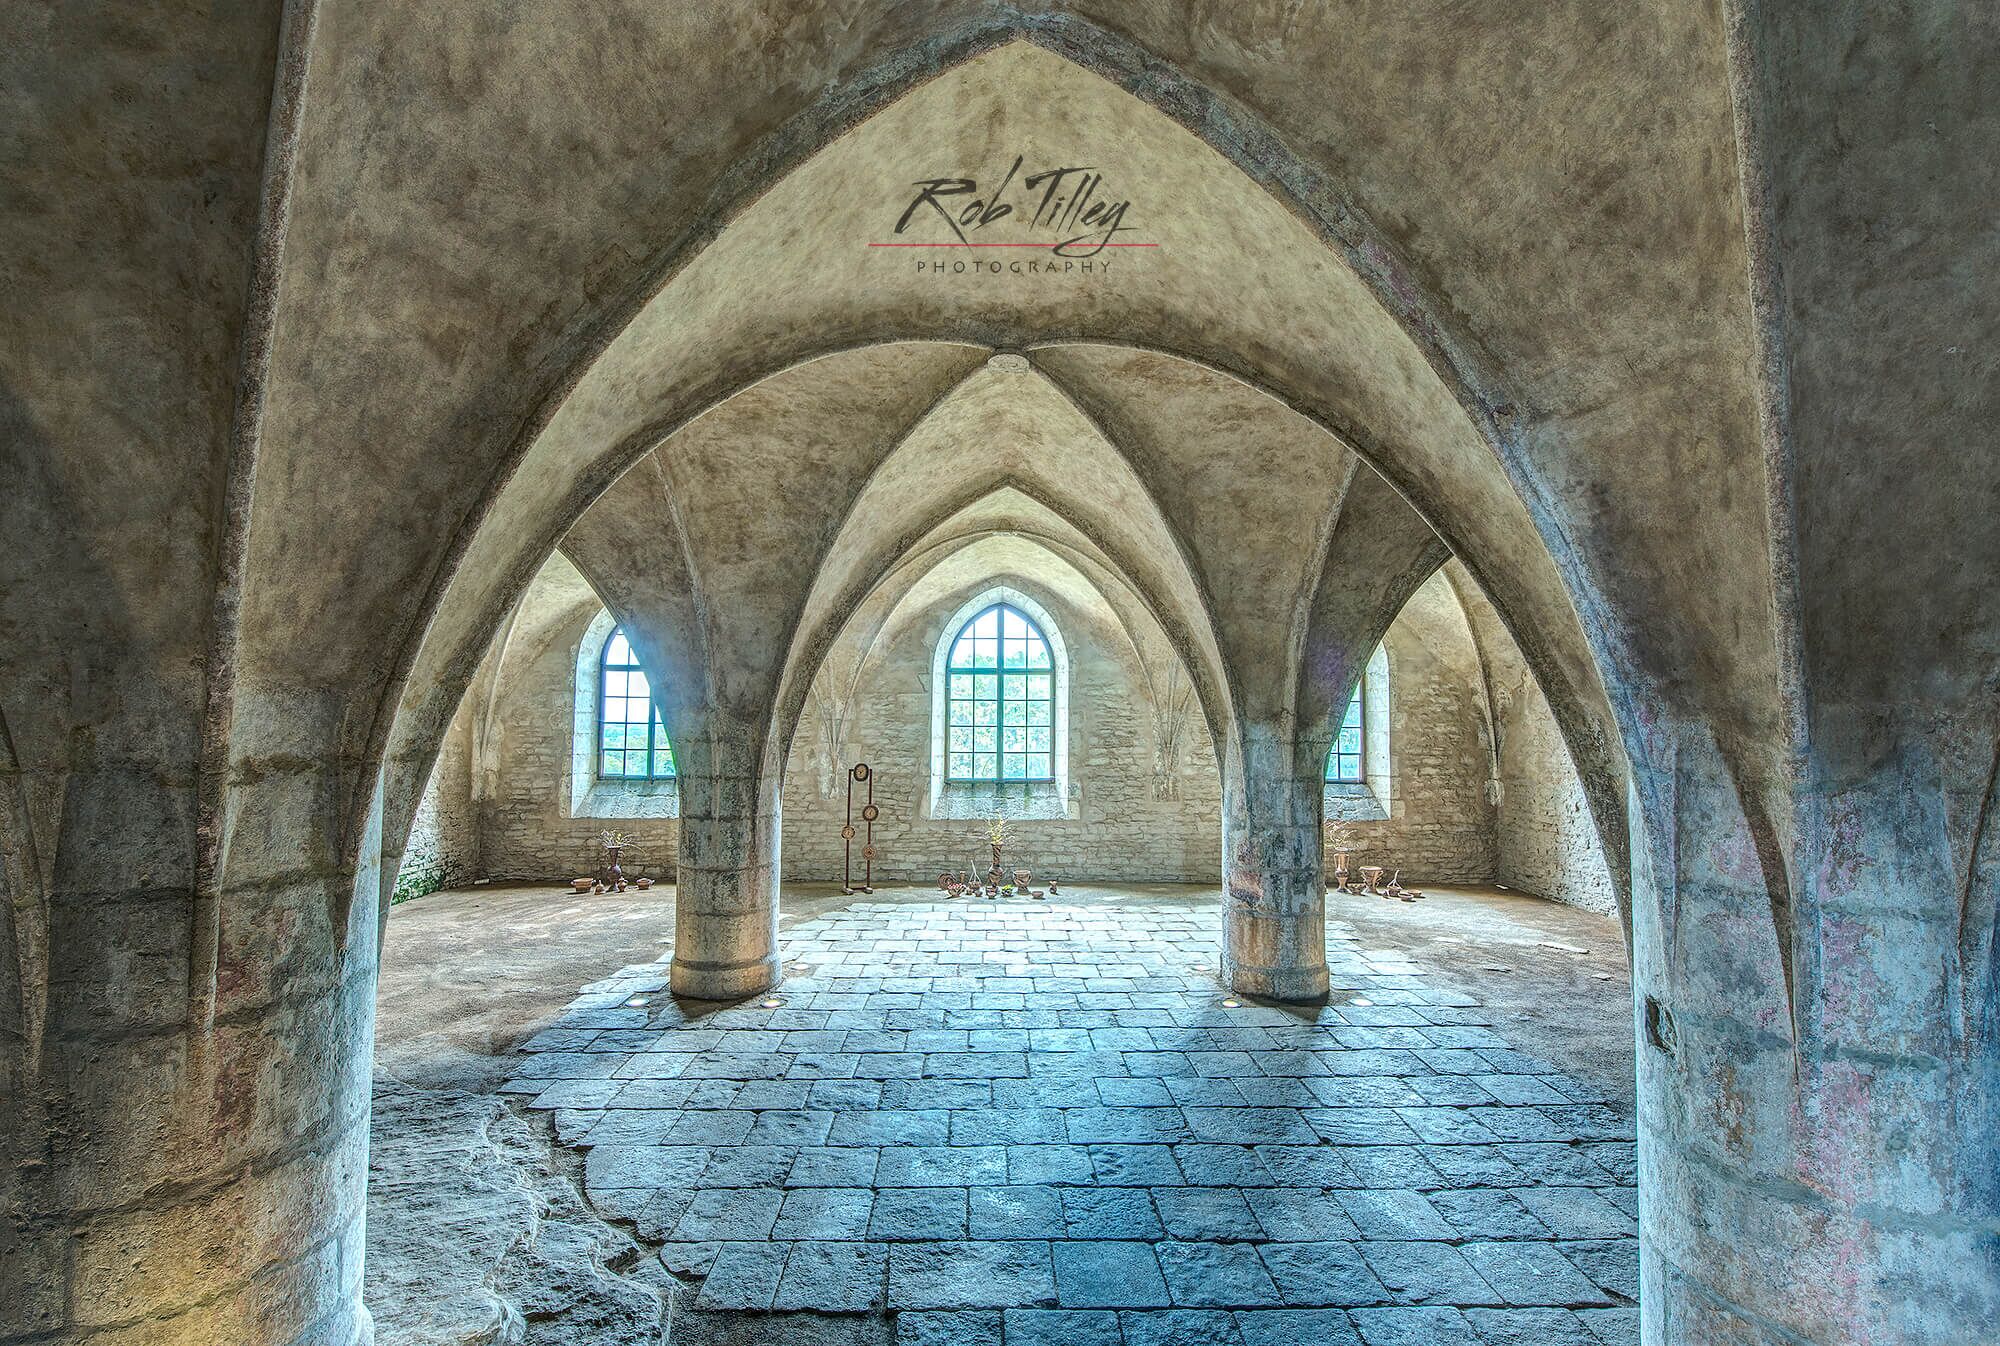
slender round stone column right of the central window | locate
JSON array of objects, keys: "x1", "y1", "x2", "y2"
[{"x1": 1222, "y1": 724, "x2": 1326, "y2": 1002}]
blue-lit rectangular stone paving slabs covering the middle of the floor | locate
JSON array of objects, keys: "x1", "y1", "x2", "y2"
[{"x1": 504, "y1": 900, "x2": 1638, "y2": 1346}]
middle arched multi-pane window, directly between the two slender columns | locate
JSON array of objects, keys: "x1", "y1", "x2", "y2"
[{"x1": 944, "y1": 602, "x2": 1056, "y2": 782}]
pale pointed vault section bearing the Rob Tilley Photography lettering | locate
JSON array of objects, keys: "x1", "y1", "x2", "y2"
[{"x1": 368, "y1": 42, "x2": 1648, "y2": 860}]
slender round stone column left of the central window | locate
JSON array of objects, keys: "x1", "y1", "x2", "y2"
[{"x1": 672, "y1": 712, "x2": 780, "y2": 1000}]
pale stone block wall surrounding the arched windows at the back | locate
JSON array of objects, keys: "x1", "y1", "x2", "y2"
[{"x1": 404, "y1": 560, "x2": 1610, "y2": 896}]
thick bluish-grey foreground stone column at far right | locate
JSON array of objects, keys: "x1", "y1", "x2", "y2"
[{"x1": 1632, "y1": 724, "x2": 2000, "y2": 1346}]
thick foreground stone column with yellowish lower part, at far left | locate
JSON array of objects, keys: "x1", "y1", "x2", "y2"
[{"x1": 0, "y1": 694, "x2": 380, "y2": 1346}]
